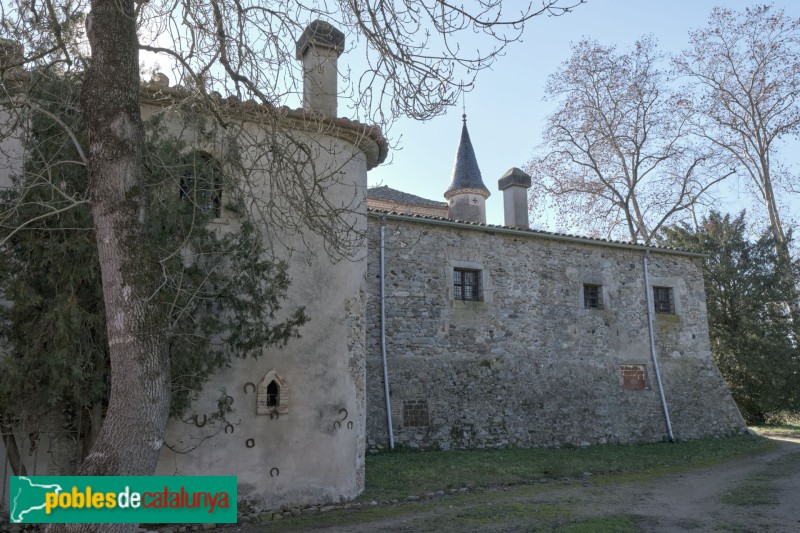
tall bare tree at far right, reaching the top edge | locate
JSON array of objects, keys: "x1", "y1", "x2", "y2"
[{"x1": 675, "y1": 6, "x2": 800, "y2": 278}]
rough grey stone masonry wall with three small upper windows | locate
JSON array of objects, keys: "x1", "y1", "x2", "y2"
[{"x1": 367, "y1": 215, "x2": 744, "y2": 449}]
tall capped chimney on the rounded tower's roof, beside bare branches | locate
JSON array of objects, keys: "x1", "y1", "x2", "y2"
[{"x1": 297, "y1": 20, "x2": 344, "y2": 117}]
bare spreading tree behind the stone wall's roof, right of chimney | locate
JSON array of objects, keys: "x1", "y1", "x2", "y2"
[{"x1": 530, "y1": 38, "x2": 730, "y2": 243}]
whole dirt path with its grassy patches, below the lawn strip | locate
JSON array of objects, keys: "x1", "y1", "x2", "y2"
[{"x1": 237, "y1": 439, "x2": 800, "y2": 533}]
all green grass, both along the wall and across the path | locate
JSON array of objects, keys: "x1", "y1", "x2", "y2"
[{"x1": 264, "y1": 435, "x2": 776, "y2": 533}]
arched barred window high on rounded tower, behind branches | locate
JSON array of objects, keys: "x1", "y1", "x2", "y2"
[{"x1": 180, "y1": 152, "x2": 222, "y2": 218}]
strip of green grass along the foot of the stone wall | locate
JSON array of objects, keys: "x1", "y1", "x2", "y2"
[{"x1": 359, "y1": 435, "x2": 775, "y2": 501}]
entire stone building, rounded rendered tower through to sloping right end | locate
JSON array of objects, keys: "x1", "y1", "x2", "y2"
[{"x1": 0, "y1": 22, "x2": 743, "y2": 507}]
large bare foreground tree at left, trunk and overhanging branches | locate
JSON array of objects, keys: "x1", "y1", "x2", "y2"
[{"x1": 0, "y1": 0, "x2": 581, "y2": 529}]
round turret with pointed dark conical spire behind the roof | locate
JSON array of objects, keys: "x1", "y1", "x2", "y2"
[{"x1": 444, "y1": 114, "x2": 491, "y2": 224}]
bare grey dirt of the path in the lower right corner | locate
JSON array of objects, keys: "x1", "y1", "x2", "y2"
[{"x1": 556, "y1": 440, "x2": 800, "y2": 532}]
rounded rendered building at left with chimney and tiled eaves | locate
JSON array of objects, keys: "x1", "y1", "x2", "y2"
[{"x1": 0, "y1": 21, "x2": 388, "y2": 509}]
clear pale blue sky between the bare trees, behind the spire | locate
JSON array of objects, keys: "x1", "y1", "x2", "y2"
[{"x1": 354, "y1": 0, "x2": 800, "y2": 229}]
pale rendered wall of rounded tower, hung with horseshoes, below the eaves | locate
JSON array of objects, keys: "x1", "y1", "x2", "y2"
[{"x1": 158, "y1": 115, "x2": 367, "y2": 508}]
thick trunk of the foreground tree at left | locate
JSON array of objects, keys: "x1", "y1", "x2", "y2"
[{"x1": 51, "y1": 0, "x2": 170, "y2": 531}]
